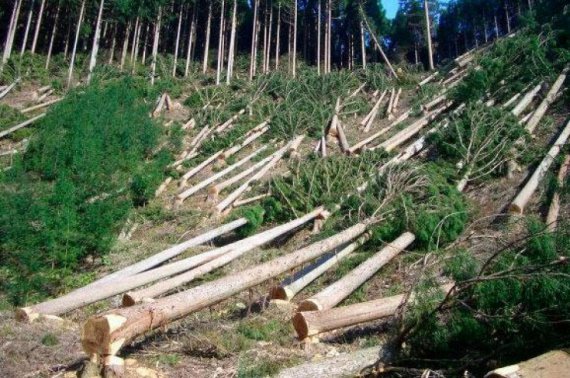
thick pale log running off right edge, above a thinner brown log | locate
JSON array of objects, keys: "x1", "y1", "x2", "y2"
[{"x1": 509, "y1": 121, "x2": 570, "y2": 214}]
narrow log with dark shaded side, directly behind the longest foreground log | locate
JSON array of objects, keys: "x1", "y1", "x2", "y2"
[{"x1": 269, "y1": 233, "x2": 370, "y2": 301}]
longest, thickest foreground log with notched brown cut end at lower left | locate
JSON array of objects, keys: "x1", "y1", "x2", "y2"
[{"x1": 81, "y1": 223, "x2": 367, "y2": 356}]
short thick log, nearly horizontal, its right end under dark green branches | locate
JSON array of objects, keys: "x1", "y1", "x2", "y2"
[{"x1": 292, "y1": 284, "x2": 453, "y2": 340}]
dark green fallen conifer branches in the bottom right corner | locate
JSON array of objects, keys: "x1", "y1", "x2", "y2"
[{"x1": 402, "y1": 219, "x2": 570, "y2": 371}]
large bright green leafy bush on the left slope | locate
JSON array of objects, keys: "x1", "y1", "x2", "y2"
[{"x1": 0, "y1": 79, "x2": 169, "y2": 304}]
